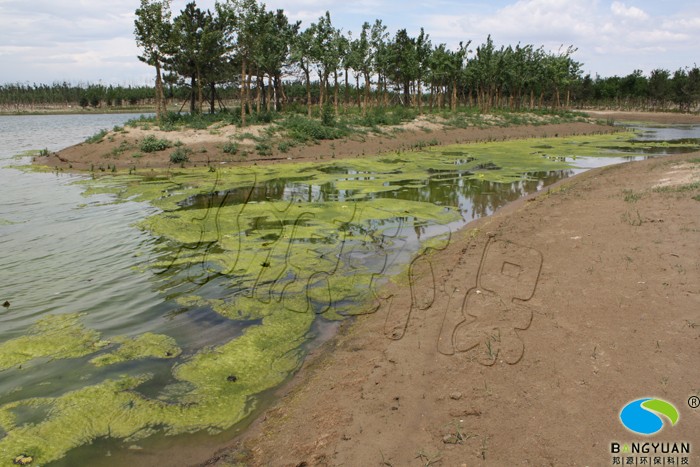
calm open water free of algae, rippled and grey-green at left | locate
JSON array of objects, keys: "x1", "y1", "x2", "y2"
[{"x1": 0, "y1": 115, "x2": 700, "y2": 465}]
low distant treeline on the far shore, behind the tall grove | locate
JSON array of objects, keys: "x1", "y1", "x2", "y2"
[{"x1": 0, "y1": 66, "x2": 700, "y2": 112}]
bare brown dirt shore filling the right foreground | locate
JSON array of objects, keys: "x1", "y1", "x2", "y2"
[{"x1": 191, "y1": 115, "x2": 700, "y2": 466}]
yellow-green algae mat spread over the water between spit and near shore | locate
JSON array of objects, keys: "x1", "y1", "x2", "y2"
[{"x1": 0, "y1": 133, "x2": 700, "y2": 465}]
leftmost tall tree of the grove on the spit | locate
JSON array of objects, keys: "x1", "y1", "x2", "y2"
[{"x1": 134, "y1": 0, "x2": 172, "y2": 120}]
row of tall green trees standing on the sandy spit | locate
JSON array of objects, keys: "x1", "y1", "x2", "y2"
[{"x1": 135, "y1": 0, "x2": 581, "y2": 121}]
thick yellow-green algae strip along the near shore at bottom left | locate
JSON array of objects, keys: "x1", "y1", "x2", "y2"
[{"x1": 0, "y1": 311, "x2": 313, "y2": 465}]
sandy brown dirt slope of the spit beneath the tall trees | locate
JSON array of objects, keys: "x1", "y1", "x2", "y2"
[{"x1": 39, "y1": 115, "x2": 616, "y2": 172}]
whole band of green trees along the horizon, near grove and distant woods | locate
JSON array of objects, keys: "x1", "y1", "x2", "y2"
[{"x1": 0, "y1": 0, "x2": 700, "y2": 117}]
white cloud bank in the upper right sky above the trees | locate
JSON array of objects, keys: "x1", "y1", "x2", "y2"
[{"x1": 424, "y1": 0, "x2": 700, "y2": 76}]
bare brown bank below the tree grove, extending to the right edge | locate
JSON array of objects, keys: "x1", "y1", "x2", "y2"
[{"x1": 33, "y1": 112, "x2": 700, "y2": 173}]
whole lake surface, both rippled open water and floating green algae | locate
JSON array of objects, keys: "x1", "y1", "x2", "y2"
[{"x1": 0, "y1": 115, "x2": 700, "y2": 465}]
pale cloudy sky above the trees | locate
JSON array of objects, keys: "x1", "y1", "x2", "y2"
[{"x1": 0, "y1": 0, "x2": 700, "y2": 85}]
